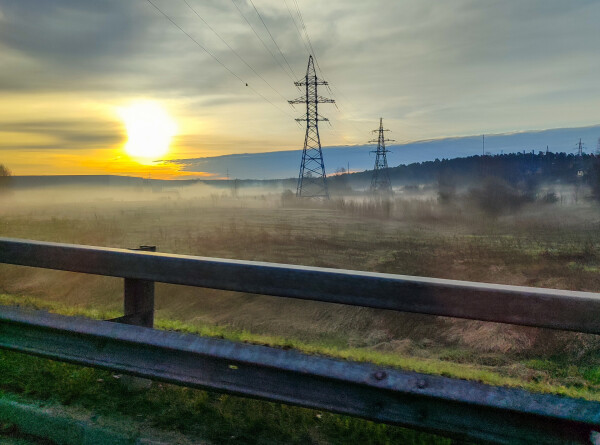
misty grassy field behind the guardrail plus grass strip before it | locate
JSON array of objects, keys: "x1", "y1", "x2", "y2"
[{"x1": 0, "y1": 184, "x2": 600, "y2": 443}]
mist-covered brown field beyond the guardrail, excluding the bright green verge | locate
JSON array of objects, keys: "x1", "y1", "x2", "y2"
[{"x1": 0, "y1": 170, "x2": 600, "y2": 358}]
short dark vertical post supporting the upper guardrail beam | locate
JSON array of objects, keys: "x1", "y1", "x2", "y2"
[{"x1": 119, "y1": 246, "x2": 156, "y2": 328}]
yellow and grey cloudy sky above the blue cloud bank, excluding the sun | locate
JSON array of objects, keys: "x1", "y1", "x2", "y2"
[{"x1": 0, "y1": 0, "x2": 600, "y2": 178}]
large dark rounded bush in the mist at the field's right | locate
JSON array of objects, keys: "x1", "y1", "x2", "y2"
[{"x1": 468, "y1": 177, "x2": 530, "y2": 217}]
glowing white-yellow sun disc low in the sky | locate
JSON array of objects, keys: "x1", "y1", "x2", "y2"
[{"x1": 119, "y1": 102, "x2": 177, "y2": 160}]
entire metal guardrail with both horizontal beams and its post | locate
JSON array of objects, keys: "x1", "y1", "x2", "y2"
[{"x1": 0, "y1": 234, "x2": 600, "y2": 444}]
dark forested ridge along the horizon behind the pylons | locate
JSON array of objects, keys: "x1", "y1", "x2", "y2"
[{"x1": 2, "y1": 151, "x2": 600, "y2": 189}]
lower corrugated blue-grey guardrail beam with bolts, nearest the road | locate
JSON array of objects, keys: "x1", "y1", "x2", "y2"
[{"x1": 0, "y1": 307, "x2": 600, "y2": 444}]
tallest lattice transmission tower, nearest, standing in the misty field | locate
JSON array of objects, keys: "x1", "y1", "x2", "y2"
[{"x1": 289, "y1": 56, "x2": 335, "y2": 199}]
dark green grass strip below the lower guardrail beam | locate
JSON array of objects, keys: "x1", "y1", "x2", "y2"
[{"x1": 0, "y1": 310, "x2": 452, "y2": 445}]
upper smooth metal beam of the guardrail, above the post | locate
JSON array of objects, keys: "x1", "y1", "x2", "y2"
[{"x1": 0, "y1": 238, "x2": 600, "y2": 334}]
